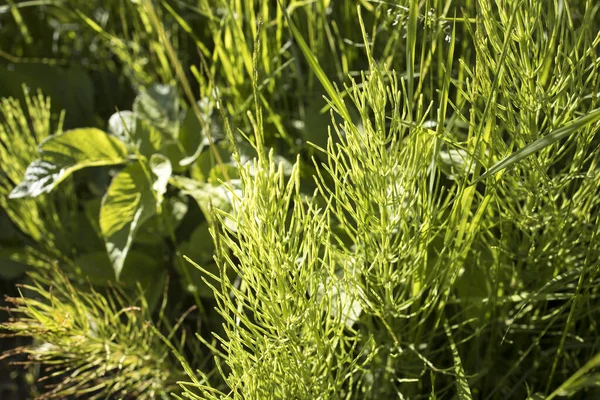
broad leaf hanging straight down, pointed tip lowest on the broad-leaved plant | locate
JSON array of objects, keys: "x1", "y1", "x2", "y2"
[{"x1": 100, "y1": 163, "x2": 156, "y2": 279}]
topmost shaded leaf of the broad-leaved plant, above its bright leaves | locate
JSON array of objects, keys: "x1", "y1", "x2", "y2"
[{"x1": 133, "y1": 84, "x2": 179, "y2": 138}]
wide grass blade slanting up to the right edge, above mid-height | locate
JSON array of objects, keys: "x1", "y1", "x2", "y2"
[{"x1": 474, "y1": 108, "x2": 600, "y2": 183}]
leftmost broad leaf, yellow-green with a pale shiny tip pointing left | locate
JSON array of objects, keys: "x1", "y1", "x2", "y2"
[{"x1": 10, "y1": 128, "x2": 127, "y2": 199}]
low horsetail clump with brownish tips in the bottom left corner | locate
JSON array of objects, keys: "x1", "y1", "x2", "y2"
[{"x1": 0, "y1": 268, "x2": 182, "y2": 399}]
